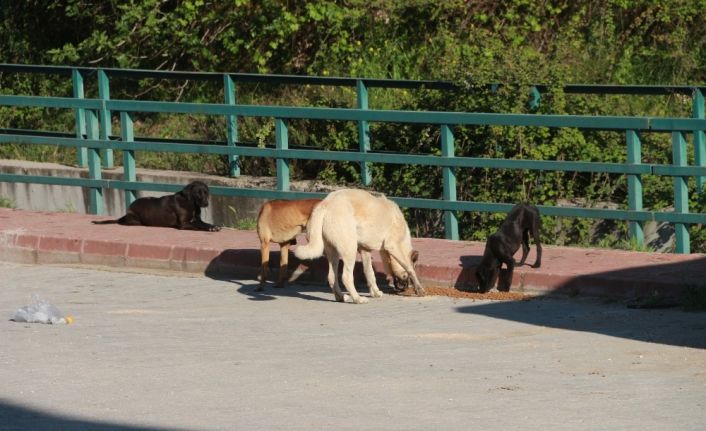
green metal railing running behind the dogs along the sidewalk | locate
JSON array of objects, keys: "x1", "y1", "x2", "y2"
[{"x1": 0, "y1": 65, "x2": 706, "y2": 253}]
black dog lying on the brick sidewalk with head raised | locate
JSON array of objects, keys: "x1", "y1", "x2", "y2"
[{"x1": 93, "y1": 181, "x2": 221, "y2": 232}]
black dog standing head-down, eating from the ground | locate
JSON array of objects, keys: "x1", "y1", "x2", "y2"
[{"x1": 476, "y1": 204, "x2": 542, "y2": 292}]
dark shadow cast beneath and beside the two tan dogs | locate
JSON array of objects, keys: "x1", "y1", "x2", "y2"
[{"x1": 204, "y1": 249, "x2": 391, "y2": 302}]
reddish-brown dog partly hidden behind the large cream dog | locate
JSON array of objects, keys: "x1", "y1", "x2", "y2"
[{"x1": 256, "y1": 199, "x2": 321, "y2": 291}]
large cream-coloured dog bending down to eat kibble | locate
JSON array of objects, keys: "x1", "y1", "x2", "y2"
[{"x1": 294, "y1": 189, "x2": 424, "y2": 304}]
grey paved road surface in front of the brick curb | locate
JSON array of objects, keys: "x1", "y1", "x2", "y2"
[{"x1": 0, "y1": 262, "x2": 706, "y2": 431}]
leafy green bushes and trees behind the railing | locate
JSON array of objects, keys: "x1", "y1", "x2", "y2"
[{"x1": 0, "y1": 0, "x2": 706, "y2": 251}]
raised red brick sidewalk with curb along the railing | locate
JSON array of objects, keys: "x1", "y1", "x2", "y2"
[{"x1": 0, "y1": 208, "x2": 706, "y2": 298}]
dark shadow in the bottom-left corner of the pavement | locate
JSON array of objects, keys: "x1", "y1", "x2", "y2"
[{"x1": 0, "y1": 399, "x2": 192, "y2": 431}]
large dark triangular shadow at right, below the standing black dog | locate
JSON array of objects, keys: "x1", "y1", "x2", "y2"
[{"x1": 457, "y1": 256, "x2": 706, "y2": 349}]
